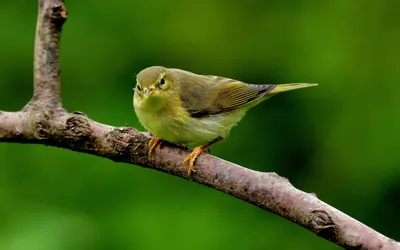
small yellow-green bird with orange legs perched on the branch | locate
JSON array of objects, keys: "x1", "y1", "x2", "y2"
[{"x1": 133, "y1": 66, "x2": 317, "y2": 176}]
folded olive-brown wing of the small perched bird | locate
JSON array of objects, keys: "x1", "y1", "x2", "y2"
[{"x1": 181, "y1": 76, "x2": 275, "y2": 118}]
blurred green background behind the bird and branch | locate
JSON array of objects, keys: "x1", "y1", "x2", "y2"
[{"x1": 0, "y1": 0, "x2": 400, "y2": 250}]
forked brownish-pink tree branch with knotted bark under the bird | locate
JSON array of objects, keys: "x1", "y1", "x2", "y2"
[{"x1": 0, "y1": 0, "x2": 400, "y2": 250}]
